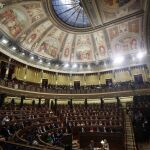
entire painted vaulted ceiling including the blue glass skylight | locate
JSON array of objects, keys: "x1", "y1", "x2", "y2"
[{"x1": 0, "y1": 0, "x2": 148, "y2": 72}]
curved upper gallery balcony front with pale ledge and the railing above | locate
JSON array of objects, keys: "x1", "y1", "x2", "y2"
[{"x1": 0, "y1": 80, "x2": 150, "y2": 99}]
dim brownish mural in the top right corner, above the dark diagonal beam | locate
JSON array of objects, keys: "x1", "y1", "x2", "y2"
[{"x1": 101, "y1": 0, "x2": 142, "y2": 22}]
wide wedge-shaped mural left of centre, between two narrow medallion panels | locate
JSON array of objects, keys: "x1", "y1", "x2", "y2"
[{"x1": 34, "y1": 28, "x2": 65, "y2": 59}]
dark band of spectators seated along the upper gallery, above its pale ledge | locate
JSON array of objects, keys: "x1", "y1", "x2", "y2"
[{"x1": 0, "y1": 79, "x2": 150, "y2": 94}]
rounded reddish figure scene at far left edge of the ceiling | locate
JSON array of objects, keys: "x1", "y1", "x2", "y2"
[{"x1": 0, "y1": 7, "x2": 30, "y2": 37}]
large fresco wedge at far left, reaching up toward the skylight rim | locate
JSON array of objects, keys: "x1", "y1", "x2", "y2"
[{"x1": 0, "y1": 2, "x2": 46, "y2": 38}]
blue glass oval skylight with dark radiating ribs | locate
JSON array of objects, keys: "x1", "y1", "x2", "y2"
[{"x1": 52, "y1": 0, "x2": 90, "y2": 28}]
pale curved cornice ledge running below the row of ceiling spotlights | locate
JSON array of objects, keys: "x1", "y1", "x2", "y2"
[{"x1": 0, "y1": 45, "x2": 150, "y2": 74}]
